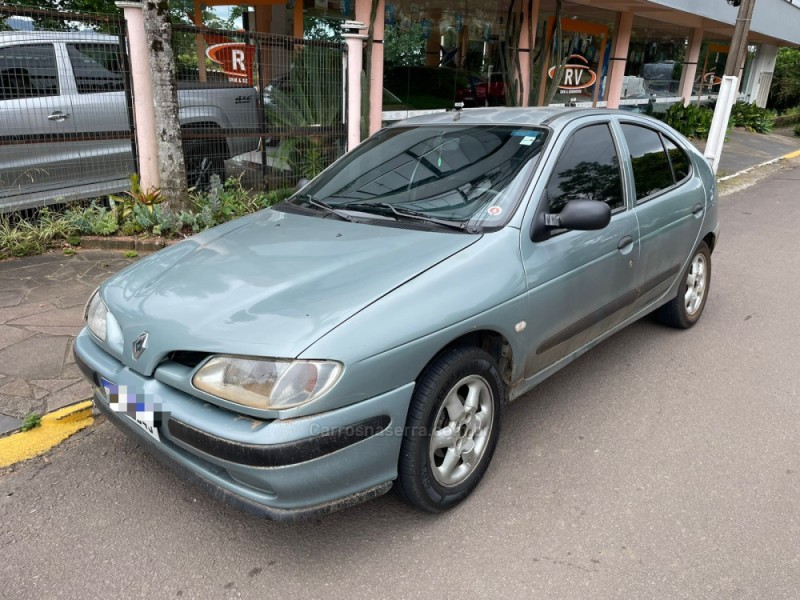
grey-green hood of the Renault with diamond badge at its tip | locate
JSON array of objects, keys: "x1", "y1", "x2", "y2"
[{"x1": 101, "y1": 210, "x2": 480, "y2": 371}]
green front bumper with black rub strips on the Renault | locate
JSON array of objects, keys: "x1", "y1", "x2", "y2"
[{"x1": 74, "y1": 330, "x2": 413, "y2": 521}]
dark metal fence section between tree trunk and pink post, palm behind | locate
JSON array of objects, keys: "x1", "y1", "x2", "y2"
[{"x1": 172, "y1": 25, "x2": 346, "y2": 190}]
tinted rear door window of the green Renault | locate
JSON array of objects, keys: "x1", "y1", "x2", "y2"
[{"x1": 622, "y1": 123, "x2": 675, "y2": 201}]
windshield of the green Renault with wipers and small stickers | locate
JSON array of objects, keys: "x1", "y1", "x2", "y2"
[{"x1": 295, "y1": 124, "x2": 547, "y2": 229}]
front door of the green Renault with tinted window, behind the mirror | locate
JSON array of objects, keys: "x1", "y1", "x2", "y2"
[{"x1": 521, "y1": 121, "x2": 639, "y2": 378}]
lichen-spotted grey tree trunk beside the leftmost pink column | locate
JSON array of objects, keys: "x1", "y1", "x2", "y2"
[{"x1": 142, "y1": 0, "x2": 189, "y2": 212}]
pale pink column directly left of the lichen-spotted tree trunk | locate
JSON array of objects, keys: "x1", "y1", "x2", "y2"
[{"x1": 115, "y1": 2, "x2": 161, "y2": 190}]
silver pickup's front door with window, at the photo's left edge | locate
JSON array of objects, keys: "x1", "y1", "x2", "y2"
[{"x1": 0, "y1": 43, "x2": 80, "y2": 209}]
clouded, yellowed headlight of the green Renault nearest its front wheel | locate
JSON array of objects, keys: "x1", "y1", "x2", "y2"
[{"x1": 192, "y1": 356, "x2": 342, "y2": 410}]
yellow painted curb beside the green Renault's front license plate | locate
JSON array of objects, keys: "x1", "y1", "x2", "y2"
[{"x1": 0, "y1": 400, "x2": 94, "y2": 468}]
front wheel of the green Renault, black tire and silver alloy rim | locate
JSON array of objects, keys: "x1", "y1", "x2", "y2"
[{"x1": 395, "y1": 347, "x2": 506, "y2": 513}]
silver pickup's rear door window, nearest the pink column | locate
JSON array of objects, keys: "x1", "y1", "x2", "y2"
[{"x1": 67, "y1": 44, "x2": 125, "y2": 94}]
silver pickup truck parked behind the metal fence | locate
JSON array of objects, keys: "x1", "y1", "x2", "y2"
[{"x1": 0, "y1": 31, "x2": 259, "y2": 213}]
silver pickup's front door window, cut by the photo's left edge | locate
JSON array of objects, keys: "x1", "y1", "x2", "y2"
[{"x1": 0, "y1": 44, "x2": 59, "y2": 100}]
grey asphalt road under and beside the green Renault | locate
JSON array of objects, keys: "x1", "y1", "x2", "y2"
[{"x1": 0, "y1": 161, "x2": 800, "y2": 599}]
